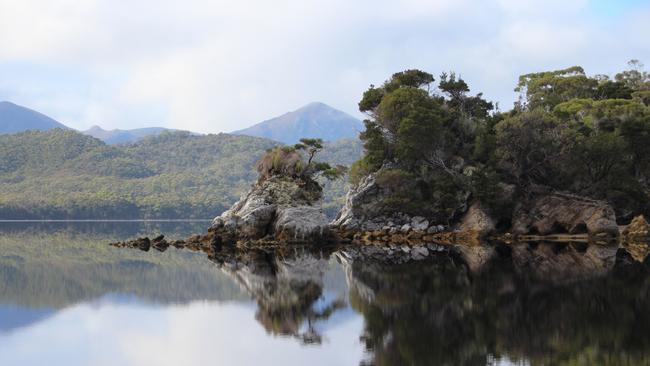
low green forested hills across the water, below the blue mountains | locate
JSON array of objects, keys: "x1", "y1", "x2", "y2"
[{"x1": 0, "y1": 129, "x2": 360, "y2": 219}]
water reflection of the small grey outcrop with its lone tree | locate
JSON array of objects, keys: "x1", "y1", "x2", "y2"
[{"x1": 213, "y1": 248, "x2": 346, "y2": 344}]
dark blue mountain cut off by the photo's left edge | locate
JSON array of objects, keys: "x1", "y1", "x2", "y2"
[{"x1": 0, "y1": 102, "x2": 68, "y2": 134}]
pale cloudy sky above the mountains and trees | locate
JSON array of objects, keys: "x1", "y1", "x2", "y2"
[{"x1": 0, "y1": 0, "x2": 650, "y2": 133}]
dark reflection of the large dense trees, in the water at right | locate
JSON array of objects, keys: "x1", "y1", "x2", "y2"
[{"x1": 340, "y1": 249, "x2": 650, "y2": 365}]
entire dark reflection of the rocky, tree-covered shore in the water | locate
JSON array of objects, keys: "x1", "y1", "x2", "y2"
[{"x1": 110, "y1": 232, "x2": 650, "y2": 365}]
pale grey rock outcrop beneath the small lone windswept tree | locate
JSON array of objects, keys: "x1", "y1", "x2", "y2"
[{"x1": 212, "y1": 176, "x2": 329, "y2": 241}]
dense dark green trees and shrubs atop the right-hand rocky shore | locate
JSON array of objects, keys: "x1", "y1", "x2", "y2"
[{"x1": 350, "y1": 60, "x2": 650, "y2": 221}]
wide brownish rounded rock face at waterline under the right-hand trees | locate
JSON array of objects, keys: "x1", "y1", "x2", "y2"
[{"x1": 512, "y1": 193, "x2": 618, "y2": 237}]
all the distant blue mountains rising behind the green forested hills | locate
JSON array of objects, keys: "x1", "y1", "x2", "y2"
[{"x1": 0, "y1": 102, "x2": 364, "y2": 145}]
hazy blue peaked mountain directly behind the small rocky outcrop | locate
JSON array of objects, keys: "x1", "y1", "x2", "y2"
[{"x1": 233, "y1": 102, "x2": 364, "y2": 144}]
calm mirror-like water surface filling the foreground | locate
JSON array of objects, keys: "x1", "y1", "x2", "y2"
[{"x1": 0, "y1": 223, "x2": 650, "y2": 366}]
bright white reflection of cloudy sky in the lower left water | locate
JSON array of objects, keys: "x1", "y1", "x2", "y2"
[{"x1": 0, "y1": 301, "x2": 363, "y2": 366}]
